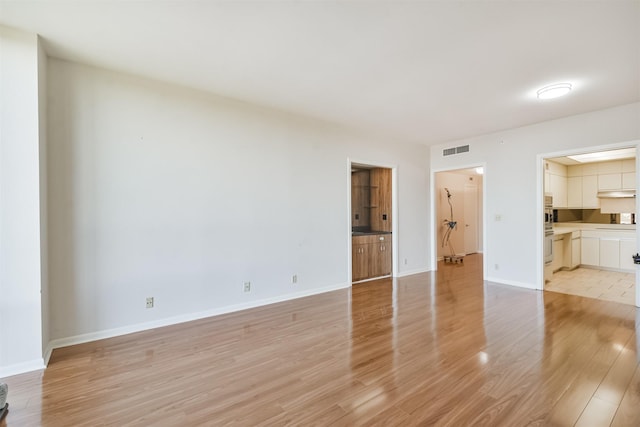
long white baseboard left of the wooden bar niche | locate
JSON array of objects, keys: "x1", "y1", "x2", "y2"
[{"x1": 45, "y1": 283, "x2": 351, "y2": 358}]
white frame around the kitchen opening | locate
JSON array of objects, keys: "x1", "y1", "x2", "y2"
[{"x1": 536, "y1": 139, "x2": 640, "y2": 307}]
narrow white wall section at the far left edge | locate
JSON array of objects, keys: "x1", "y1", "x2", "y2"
[{"x1": 0, "y1": 26, "x2": 43, "y2": 377}]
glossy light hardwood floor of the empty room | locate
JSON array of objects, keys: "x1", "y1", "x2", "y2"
[{"x1": 0, "y1": 255, "x2": 640, "y2": 427}]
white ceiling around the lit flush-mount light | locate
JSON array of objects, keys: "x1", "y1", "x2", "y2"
[{"x1": 0, "y1": 0, "x2": 640, "y2": 144}]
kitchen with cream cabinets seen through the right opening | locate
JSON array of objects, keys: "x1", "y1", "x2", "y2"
[{"x1": 544, "y1": 148, "x2": 637, "y2": 305}]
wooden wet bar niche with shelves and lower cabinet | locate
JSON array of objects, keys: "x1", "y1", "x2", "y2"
[{"x1": 351, "y1": 164, "x2": 393, "y2": 283}]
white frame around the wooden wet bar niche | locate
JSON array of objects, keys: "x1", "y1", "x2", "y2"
[{"x1": 347, "y1": 157, "x2": 398, "y2": 285}]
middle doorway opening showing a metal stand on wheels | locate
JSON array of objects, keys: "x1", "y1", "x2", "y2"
[{"x1": 433, "y1": 166, "x2": 484, "y2": 265}]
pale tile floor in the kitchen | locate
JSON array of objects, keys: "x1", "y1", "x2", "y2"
[{"x1": 544, "y1": 268, "x2": 636, "y2": 305}]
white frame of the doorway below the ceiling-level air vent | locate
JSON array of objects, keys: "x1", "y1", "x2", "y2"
[{"x1": 430, "y1": 162, "x2": 489, "y2": 274}]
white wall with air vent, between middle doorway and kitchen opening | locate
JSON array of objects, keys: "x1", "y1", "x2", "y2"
[{"x1": 431, "y1": 103, "x2": 640, "y2": 288}]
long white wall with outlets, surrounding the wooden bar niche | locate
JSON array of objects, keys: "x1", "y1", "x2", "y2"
[{"x1": 48, "y1": 59, "x2": 430, "y2": 345}]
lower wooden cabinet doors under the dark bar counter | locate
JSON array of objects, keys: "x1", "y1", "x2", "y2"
[{"x1": 351, "y1": 234, "x2": 392, "y2": 282}]
